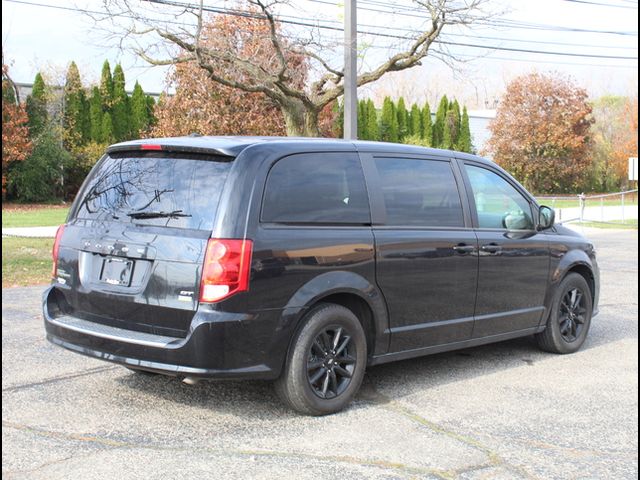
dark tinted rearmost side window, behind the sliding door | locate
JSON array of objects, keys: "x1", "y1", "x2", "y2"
[{"x1": 262, "y1": 153, "x2": 371, "y2": 224}]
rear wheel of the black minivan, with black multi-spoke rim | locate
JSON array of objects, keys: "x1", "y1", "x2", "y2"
[{"x1": 275, "y1": 303, "x2": 367, "y2": 416}]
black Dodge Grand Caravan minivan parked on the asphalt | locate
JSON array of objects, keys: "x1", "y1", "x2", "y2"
[{"x1": 43, "y1": 136, "x2": 599, "y2": 415}]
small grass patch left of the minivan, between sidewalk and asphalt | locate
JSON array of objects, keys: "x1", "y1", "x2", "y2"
[{"x1": 2, "y1": 235, "x2": 53, "y2": 288}]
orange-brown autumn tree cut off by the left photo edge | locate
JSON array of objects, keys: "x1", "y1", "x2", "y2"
[{"x1": 2, "y1": 62, "x2": 31, "y2": 196}]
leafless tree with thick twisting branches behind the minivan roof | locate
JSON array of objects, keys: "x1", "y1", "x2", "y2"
[{"x1": 97, "y1": 0, "x2": 489, "y2": 136}]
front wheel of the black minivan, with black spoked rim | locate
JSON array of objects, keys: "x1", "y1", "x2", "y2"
[{"x1": 536, "y1": 273, "x2": 593, "y2": 354}]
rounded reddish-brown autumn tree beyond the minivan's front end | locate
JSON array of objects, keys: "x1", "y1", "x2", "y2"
[{"x1": 487, "y1": 73, "x2": 593, "y2": 193}]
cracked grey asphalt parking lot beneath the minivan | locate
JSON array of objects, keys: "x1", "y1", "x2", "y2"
[{"x1": 2, "y1": 230, "x2": 638, "y2": 480}]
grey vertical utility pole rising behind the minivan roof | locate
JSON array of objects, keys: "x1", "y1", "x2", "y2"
[{"x1": 344, "y1": 0, "x2": 358, "y2": 140}]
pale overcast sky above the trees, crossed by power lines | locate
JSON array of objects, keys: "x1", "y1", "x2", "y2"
[{"x1": 2, "y1": 0, "x2": 638, "y2": 108}]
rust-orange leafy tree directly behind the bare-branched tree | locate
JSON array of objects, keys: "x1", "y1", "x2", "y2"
[{"x1": 151, "y1": 10, "x2": 307, "y2": 136}]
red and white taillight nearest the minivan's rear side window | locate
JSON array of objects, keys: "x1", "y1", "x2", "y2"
[{"x1": 200, "y1": 238, "x2": 253, "y2": 302}]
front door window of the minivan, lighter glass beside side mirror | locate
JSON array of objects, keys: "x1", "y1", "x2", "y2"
[{"x1": 465, "y1": 165, "x2": 534, "y2": 230}]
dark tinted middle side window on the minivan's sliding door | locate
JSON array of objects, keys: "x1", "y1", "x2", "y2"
[{"x1": 376, "y1": 158, "x2": 464, "y2": 227}]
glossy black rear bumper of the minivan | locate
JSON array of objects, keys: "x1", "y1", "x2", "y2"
[{"x1": 43, "y1": 286, "x2": 289, "y2": 379}]
